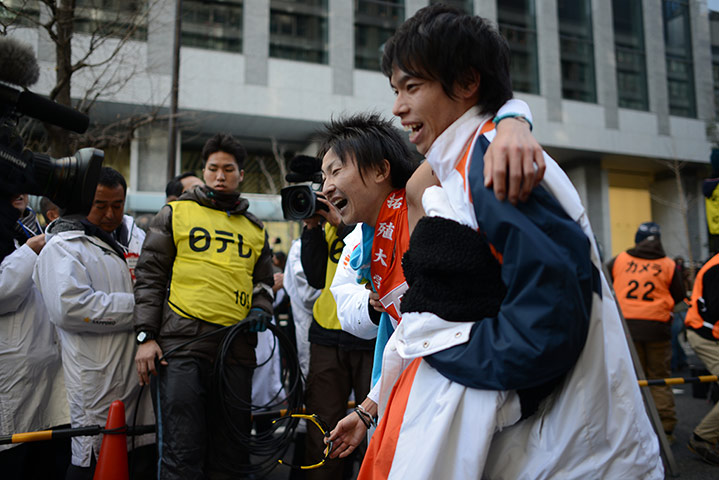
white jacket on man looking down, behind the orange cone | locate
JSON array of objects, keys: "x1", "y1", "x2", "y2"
[{"x1": 33, "y1": 215, "x2": 154, "y2": 466}]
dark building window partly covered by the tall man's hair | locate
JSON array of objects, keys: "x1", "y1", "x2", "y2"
[{"x1": 355, "y1": 0, "x2": 404, "y2": 70}]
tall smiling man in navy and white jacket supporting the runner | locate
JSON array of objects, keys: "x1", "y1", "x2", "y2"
[{"x1": 331, "y1": 5, "x2": 663, "y2": 479}]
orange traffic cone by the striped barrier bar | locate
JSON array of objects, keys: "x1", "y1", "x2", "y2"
[{"x1": 93, "y1": 400, "x2": 130, "y2": 480}]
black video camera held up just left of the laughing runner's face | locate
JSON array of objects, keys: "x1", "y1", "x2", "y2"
[{"x1": 280, "y1": 155, "x2": 328, "y2": 220}]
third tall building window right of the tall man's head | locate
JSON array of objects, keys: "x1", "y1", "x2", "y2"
[{"x1": 612, "y1": 0, "x2": 649, "y2": 110}]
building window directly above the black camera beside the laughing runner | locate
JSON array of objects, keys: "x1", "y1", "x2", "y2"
[{"x1": 270, "y1": 0, "x2": 328, "y2": 64}]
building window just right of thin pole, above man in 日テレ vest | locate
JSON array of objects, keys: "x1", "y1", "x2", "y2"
[{"x1": 182, "y1": 0, "x2": 242, "y2": 53}]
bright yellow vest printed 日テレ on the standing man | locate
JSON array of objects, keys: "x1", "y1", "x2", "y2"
[{"x1": 168, "y1": 201, "x2": 265, "y2": 326}]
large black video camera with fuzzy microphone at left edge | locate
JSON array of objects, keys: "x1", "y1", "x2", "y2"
[{"x1": 0, "y1": 37, "x2": 104, "y2": 215}]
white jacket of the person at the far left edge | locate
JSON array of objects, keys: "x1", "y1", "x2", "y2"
[{"x1": 0, "y1": 245, "x2": 70, "y2": 451}]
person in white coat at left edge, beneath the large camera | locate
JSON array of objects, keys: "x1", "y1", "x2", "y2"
[{"x1": 0, "y1": 194, "x2": 70, "y2": 479}]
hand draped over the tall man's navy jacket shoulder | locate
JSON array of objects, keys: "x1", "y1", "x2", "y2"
[{"x1": 484, "y1": 118, "x2": 546, "y2": 205}]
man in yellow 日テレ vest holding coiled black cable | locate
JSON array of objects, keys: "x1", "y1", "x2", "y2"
[{"x1": 134, "y1": 134, "x2": 273, "y2": 480}]
